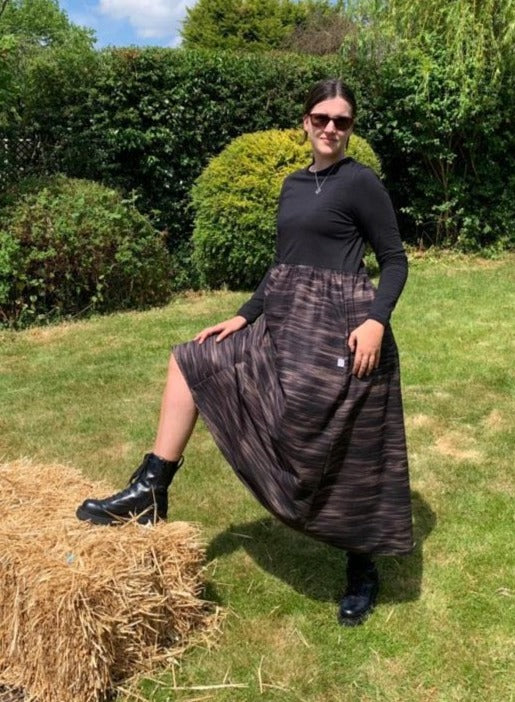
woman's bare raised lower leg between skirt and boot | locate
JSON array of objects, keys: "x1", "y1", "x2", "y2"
[{"x1": 152, "y1": 353, "x2": 198, "y2": 461}]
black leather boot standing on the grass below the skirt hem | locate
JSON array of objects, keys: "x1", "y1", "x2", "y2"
[{"x1": 338, "y1": 553, "x2": 379, "y2": 626}]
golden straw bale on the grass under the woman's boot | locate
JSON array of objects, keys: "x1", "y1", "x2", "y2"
[{"x1": 0, "y1": 459, "x2": 220, "y2": 702}]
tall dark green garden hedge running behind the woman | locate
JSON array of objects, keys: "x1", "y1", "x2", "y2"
[{"x1": 0, "y1": 44, "x2": 514, "y2": 272}]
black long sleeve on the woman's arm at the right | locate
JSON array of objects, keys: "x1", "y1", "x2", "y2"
[{"x1": 353, "y1": 168, "x2": 408, "y2": 326}]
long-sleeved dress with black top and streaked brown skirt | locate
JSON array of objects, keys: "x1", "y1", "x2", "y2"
[{"x1": 172, "y1": 157, "x2": 414, "y2": 555}]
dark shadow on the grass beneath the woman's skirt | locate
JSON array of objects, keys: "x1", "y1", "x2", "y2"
[{"x1": 206, "y1": 492, "x2": 436, "y2": 603}]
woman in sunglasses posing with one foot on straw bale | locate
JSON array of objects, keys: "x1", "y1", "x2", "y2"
[{"x1": 77, "y1": 79, "x2": 414, "y2": 625}]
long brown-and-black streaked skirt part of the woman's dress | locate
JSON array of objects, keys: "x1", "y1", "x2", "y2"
[{"x1": 172, "y1": 263, "x2": 414, "y2": 555}]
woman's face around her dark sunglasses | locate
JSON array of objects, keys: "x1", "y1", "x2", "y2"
[{"x1": 304, "y1": 97, "x2": 353, "y2": 158}]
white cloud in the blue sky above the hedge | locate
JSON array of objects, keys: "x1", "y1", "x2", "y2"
[{"x1": 99, "y1": 0, "x2": 194, "y2": 41}]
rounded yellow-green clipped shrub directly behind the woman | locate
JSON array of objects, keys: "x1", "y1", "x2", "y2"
[{"x1": 192, "y1": 129, "x2": 380, "y2": 289}]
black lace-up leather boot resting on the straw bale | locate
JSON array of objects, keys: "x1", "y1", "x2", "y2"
[{"x1": 76, "y1": 453, "x2": 184, "y2": 524}]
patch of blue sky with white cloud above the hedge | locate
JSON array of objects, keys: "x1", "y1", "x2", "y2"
[{"x1": 59, "y1": 0, "x2": 191, "y2": 49}]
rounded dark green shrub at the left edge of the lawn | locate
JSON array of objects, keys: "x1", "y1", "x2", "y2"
[{"x1": 0, "y1": 175, "x2": 171, "y2": 328}]
